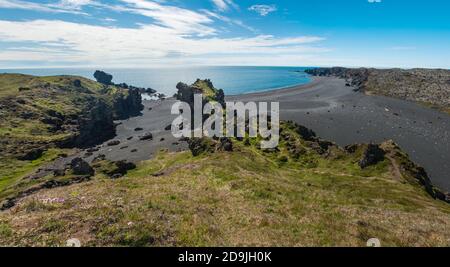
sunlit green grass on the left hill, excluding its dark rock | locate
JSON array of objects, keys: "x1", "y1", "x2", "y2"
[{"x1": 0, "y1": 74, "x2": 126, "y2": 199}]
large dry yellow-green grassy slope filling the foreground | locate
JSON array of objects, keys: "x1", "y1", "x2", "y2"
[{"x1": 0, "y1": 123, "x2": 450, "y2": 246}]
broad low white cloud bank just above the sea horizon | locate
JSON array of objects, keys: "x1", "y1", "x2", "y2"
[{"x1": 0, "y1": 20, "x2": 329, "y2": 66}]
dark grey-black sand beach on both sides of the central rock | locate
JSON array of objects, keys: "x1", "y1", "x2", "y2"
[{"x1": 85, "y1": 78, "x2": 450, "y2": 193}]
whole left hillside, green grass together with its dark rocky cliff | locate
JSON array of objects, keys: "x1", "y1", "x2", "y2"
[{"x1": 0, "y1": 74, "x2": 141, "y2": 203}]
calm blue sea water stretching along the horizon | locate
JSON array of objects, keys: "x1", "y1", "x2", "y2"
[{"x1": 0, "y1": 67, "x2": 310, "y2": 96}]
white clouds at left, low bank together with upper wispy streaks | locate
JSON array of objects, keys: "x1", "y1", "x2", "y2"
[{"x1": 0, "y1": 0, "x2": 330, "y2": 66}]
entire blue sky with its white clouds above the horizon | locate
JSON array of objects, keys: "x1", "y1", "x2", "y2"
[{"x1": 0, "y1": 0, "x2": 450, "y2": 68}]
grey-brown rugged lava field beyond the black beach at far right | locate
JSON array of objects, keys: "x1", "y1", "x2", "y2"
[{"x1": 305, "y1": 67, "x2": 450, "y2": 111}]
